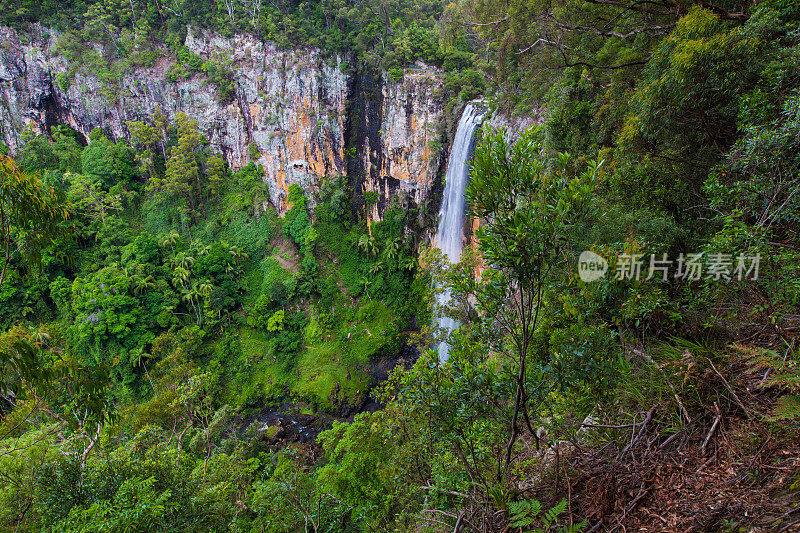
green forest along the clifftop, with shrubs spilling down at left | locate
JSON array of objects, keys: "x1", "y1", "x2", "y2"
[{"x1": 0, "y1": 0, "x2": 462, "y2": 104}]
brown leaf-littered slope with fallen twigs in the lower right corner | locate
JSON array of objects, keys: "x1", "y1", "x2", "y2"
[{"x1": 518, "y1": 342, "x2": 800, "y2": 533}]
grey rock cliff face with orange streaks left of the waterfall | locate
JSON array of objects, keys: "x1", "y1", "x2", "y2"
[{"x1": 0, "y1": 27, "x2": 443, "y2": 218}]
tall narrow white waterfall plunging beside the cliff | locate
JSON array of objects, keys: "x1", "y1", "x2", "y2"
[{"x1": 436, "y1": 103, "x2": 485, "y2": 362}]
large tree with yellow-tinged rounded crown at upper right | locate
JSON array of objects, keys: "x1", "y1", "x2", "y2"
[{"x1": 618, "y1": 8, "x2": 780, "y2": 218}]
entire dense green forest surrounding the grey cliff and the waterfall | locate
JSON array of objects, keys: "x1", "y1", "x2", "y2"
[{"x1": 0, "y1": 0, "x2": 800, "y2": 533}]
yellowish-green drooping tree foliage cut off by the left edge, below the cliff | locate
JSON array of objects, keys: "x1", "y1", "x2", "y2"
[{"x1": 0, "y1": 155, "x2": 69, "y2": 285}]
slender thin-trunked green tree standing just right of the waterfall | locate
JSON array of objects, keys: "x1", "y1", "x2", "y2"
[{"x1": 467, "y1": 125, "x2": 599, "y2": 479}]
